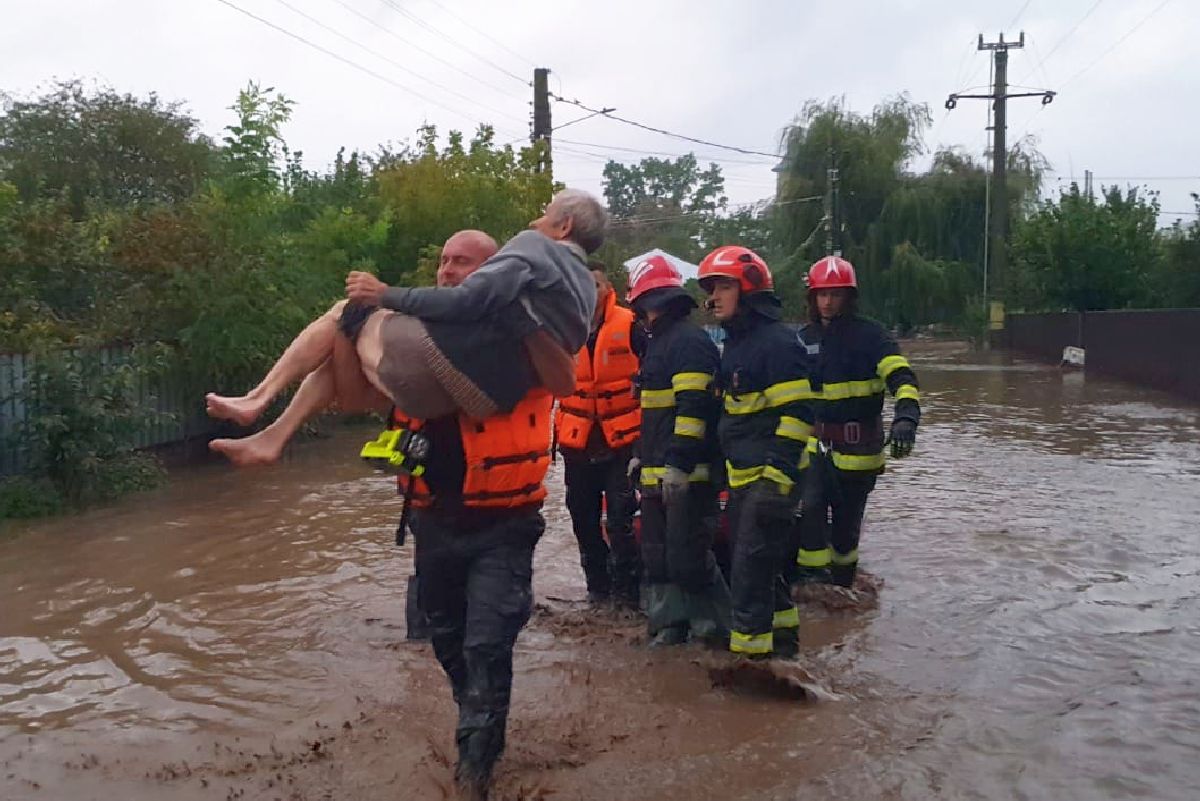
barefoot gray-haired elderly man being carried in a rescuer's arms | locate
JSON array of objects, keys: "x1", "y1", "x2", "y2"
[{"x1": 205, "y1": 189, "x2": 607, "y2": 465}]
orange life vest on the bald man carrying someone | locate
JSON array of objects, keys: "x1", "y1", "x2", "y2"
[{"x1": 391, "y1": 387, "x2": 554, "y2": 508}]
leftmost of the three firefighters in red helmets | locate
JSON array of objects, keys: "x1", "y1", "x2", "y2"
[{"x1": 629, "y1": 255, "x2": 730, "y2": 645}]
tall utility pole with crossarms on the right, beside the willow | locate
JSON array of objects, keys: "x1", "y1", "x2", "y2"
[{"x1": 946, "y1": 31, "x2": 1055, "y2": 330}]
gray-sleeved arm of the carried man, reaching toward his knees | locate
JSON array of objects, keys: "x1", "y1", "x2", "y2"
[{"x1": 379, "y1": 253, "x2": 533, "y2": 323}]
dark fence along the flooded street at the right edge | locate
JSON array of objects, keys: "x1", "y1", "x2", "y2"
[{"x1": 1006, "y1": 308, "x2": 1200, "y2": 401}]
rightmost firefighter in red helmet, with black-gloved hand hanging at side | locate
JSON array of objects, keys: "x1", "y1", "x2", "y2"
[{"x1": 796, "y1": 255, "x2": 920, "y2": 586}]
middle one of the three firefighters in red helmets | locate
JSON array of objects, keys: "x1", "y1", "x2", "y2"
[{"x1": 700, "y1": 246, "x2": 812, "y2": 657}]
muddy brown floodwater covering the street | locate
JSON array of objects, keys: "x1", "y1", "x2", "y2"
[{"x1": 0, "y1": 345, "x2": 1200, "y2": 801}]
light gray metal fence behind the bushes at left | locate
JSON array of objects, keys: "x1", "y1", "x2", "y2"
[{"x1": 0, "y1": 347, "x2": 214, "y2": 476}]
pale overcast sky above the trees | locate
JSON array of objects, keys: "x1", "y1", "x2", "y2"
[{"x1": 0, "y1": 0, "x2": 1200, "y2": 222}]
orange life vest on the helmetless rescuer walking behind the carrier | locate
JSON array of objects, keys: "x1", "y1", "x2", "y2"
[{"x1": 554, "y1": 293, "x2": 642, "y2": 450}]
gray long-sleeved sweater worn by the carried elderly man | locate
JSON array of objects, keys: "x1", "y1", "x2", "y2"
[{"x1": 380, "y1": 230, "x2": 596, "y2": 355}]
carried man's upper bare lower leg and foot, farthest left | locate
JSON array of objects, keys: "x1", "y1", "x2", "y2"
[{"x1": 204, "y1": 301, "x2": 346, "y2": 426}]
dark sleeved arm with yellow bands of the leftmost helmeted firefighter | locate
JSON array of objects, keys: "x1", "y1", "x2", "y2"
[{"x1": 664, "y1": 335, "x2": 721, "y2": 472}]
